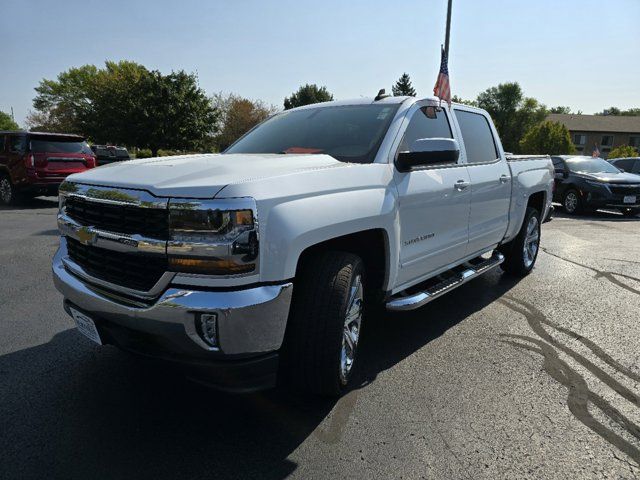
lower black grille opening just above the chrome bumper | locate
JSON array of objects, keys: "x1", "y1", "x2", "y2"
[{"x1": 67, "y1": 238, "x2": 168, "y2": 292}]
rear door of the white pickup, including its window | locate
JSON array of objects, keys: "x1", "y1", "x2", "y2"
[{"x1": 454, "y1": 108, "x2": 511, "y2": 255}]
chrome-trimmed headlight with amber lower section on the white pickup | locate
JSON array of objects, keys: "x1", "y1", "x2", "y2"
[{"x1": 167, "y1": 198, "x2": 259, "y2": 275}]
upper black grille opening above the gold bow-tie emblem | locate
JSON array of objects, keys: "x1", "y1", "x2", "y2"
[{"x1": 65, "y1": 196, "x2": 169, "y2": 240}]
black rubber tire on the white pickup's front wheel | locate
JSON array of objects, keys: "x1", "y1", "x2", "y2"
[{"x1": 280, "y1": 251, "x2": 365, "y2": 396}]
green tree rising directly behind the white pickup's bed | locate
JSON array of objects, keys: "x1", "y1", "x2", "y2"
[{"x1": 476, "y1": 82, "x2": 548, "y2": 153}]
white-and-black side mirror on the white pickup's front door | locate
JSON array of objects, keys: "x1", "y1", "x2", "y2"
[{"x1": 396, "y1": 138, "x2": 460, "y2": 172}]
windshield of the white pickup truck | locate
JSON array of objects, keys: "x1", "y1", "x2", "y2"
[{"x1": 224, "y1": 104, "x2": 399, "y2": 163}]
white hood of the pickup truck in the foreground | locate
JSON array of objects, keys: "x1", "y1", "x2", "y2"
[{"x1": 68, "y1": 154, "x2": 349, "y2": 198}]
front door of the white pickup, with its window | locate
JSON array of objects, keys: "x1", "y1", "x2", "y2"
[{"x1": 394, "y1": 102, "x2": 471, "y2": 287}]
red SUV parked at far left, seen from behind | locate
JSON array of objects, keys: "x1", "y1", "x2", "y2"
[{"x1": 0, "y1": 131, "x2": 96, "y2": 204}]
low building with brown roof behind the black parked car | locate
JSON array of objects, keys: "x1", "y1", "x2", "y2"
[{"x1": 547, "y1": 113, "x2": 640, "y2": 158}]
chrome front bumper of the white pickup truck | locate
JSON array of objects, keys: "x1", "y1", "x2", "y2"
[{"x1": 53, "y1": 242, "x2": 293, "y2": 356}]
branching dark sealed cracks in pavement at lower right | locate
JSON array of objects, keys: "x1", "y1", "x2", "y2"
[{"x1": 498, "y1": 295, "x2": 640, "y2": 466}]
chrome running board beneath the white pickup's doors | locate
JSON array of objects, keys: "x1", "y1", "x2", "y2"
[{"x1": 386, "y1": 252, "x2": 504, "y2": 312}]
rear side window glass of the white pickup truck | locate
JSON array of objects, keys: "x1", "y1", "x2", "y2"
[{"x1": 454, "y1": 110, "x2": 498, "y2": 163}]
